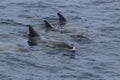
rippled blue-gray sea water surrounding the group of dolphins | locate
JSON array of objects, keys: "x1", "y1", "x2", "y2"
[{"x1": 0, "y1": 0, "x2": 120, "y2": 80}]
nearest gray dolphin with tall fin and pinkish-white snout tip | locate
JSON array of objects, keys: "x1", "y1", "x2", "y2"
[{"x1": 27, "y1": 26, "x2": 76, "y2": 52}]
